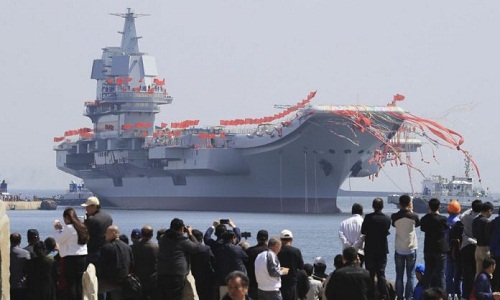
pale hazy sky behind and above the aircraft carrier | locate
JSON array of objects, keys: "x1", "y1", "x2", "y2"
[{"x1": 0, "y1": 0, "x2": 500, "y2": 192}]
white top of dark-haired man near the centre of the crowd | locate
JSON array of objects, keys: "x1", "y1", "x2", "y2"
[{"x1": 255, "y1": 250, "x2": 281, "y2": 291}]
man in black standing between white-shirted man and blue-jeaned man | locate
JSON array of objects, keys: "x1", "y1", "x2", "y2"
[{"x1": 361, "y1": 198, "x2": 391, "y2": 298}]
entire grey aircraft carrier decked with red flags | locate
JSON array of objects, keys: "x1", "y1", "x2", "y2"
[{"x1": 54, "y1": 9, "x2": 421, "y2": 213}]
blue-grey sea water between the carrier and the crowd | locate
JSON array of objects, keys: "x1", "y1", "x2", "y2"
[{"x1": 7, "y1": 197, "x2": 424, "y2": 280}]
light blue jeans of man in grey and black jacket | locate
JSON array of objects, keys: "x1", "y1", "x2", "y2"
[{"x1": 394, "y1": 250, "x2": 417, "y2": 299}]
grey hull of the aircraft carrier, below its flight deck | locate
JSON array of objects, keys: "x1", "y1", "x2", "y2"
[{"x1": 64, "y1": 113, "x2": 397, "y2": 213}]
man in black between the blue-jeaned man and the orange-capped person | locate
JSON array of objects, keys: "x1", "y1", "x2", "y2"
[{"x1": 420, "y1": 198, "x2": 449, "y2": 291}]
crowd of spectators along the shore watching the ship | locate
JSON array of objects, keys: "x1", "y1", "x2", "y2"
[{"x1": 10, "y1": 195, "x2": 500, "y2": 300}]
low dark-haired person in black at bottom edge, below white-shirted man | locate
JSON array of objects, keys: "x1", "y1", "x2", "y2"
[{"x1": 325, "y1": 247, "x2": 370, "y2": 300}]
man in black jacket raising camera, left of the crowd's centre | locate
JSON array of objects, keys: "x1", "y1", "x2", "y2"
[{"x1": 158, "y1": 218, "x2": 209, "y2": 300}]
